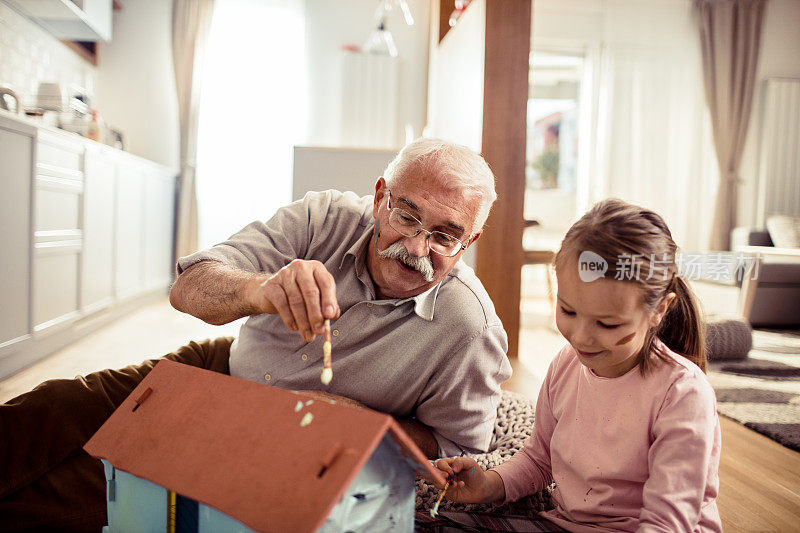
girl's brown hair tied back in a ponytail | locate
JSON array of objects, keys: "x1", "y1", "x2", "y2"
[{"x1": 554, "y1": 198, "x2": 706, "y2": 375}]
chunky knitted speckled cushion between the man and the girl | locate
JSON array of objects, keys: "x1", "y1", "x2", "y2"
[{"x1": 416, "y1": 391, "x2": 553, "y2": 515}]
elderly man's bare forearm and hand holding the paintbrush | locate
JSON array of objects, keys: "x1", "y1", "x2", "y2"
[{"x1": 169, "y1": 259, "x2": 339, "y2": 342}]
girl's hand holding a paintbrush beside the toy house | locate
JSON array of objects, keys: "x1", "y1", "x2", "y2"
[{"x1": 436, "y1": 457, "x2": 506, "y2": 503}]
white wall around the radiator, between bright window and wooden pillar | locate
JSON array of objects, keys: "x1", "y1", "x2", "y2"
[{"x1": 306, "y1": 0, "x2": 430, "y2": 146}]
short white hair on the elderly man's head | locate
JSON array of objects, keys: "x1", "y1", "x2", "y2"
[{"x1": 383, "y1": 137, "x2": 497, "y2": 232}]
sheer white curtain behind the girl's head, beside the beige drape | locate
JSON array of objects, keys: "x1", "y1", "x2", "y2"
[{"x1": 586, "y1": 2, "x2": 719, "y2": 250}]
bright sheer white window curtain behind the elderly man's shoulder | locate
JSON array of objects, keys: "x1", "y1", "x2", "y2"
[{"x1": 197, "y1": 0, "x2": 307, "y2": 248}]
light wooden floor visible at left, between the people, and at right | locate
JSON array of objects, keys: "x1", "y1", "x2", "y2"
[{"x1": 0, "y1": 298, "x2": 800, "y2": 532}]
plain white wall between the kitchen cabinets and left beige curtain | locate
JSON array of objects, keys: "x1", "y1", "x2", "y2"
[{"x1": 95, "y1": 0, "x2": 180, "y2": 171}]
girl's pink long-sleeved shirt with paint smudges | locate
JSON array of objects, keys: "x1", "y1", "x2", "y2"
[{"x1": 494, "y1": 341, "x2": 722, "y2": 532}]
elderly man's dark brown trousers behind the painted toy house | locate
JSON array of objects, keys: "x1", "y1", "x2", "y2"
[{"x1": 0, "y1": 337, "x2": 233, "y2": 532}]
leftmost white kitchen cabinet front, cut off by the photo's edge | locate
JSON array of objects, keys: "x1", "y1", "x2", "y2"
[{"x1": 0, "y1": 120, "x2": 34, "y2": 359}]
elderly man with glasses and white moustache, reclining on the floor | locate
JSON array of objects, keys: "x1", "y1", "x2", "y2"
[{"x1": 0, "y1": 139, "x2": 511, "y2": 530}]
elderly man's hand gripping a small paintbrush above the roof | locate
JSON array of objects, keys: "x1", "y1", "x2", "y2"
[{"x1": 245, "y1": 259, "x2": 339, "y2": 342}]
